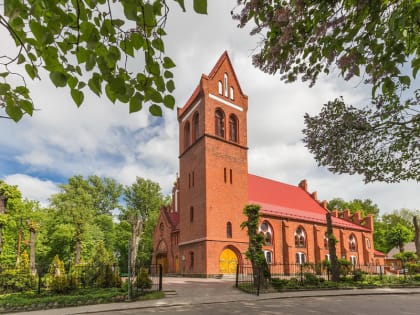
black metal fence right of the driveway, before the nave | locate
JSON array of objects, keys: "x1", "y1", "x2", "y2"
[{"x1": 236, "y1": 263, "x2": 384, "y2": 295}]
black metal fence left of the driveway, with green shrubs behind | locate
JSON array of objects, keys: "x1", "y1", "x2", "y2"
[{"x1": 0, "y1": 264, "x2": 162, "y2": 297}]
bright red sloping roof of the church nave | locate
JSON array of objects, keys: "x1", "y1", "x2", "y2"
[{"x1": 248, "y1": 174, "x2": 370, "y2": 231}]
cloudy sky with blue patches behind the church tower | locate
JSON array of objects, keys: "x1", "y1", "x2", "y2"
[{"x1": 0, "y1": 0, "x2": 420, "y2": 212}]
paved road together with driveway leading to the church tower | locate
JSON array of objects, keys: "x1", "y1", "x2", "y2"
[{"x1": 15, "y1": 278, "x2": 420, "y2": 315}]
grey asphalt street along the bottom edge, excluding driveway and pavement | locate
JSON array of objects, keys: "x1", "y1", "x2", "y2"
[{"x1": 87, "y1": 294, "x2": 420, "y2": 315}]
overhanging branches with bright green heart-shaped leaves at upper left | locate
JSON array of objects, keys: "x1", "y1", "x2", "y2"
[{"x1": 0, "y1": 0, "x2": 207, "y2": 121}]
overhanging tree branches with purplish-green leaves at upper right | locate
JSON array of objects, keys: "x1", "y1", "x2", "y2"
[{"x1": 233, "y1": 0, "x2": 420, "y2": 182}]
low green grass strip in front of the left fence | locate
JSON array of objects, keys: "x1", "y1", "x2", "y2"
[{"x1": 0, "y1": 288, "x2": 165, "y2": 313}]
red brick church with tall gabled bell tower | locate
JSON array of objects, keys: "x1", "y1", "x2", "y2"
[{"x1": 153, "y1": 52, "x2": 375, "y2": 276}]
